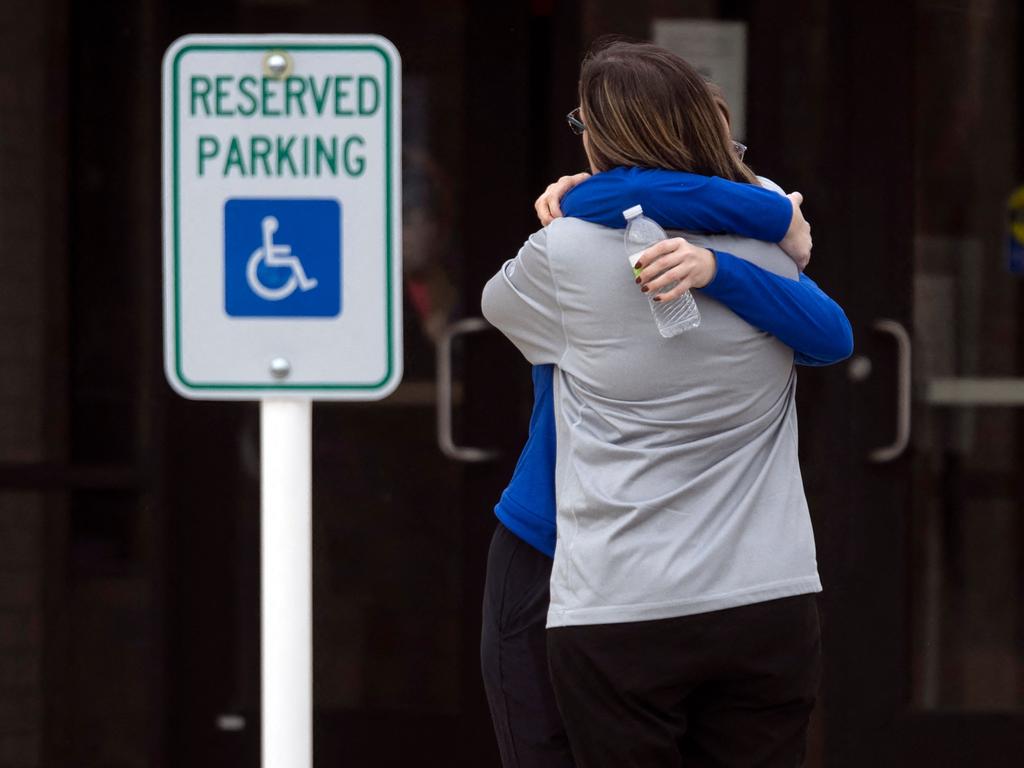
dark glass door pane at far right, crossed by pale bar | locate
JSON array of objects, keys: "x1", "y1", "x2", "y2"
[{"x1": 909, "y1": 0, "x2": 1024, "y2": 765}]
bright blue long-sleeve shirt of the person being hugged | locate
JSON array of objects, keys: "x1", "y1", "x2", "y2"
[{"x1": 495, "y1": 168, "x2": 853, "y2": 557}]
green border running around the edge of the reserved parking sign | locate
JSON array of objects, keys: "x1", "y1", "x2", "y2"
[{"x1": 171, "y1": 40, "x2": 394, "y2": 392}]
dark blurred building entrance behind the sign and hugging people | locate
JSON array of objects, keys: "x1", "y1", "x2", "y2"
[{"x1": 0, "y1": 0, "x2": 1024, "y2": 768}]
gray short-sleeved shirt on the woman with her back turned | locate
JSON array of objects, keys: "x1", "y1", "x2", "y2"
[{"x1": 482, "y1": 218, "x2": 821, "y2": 627}]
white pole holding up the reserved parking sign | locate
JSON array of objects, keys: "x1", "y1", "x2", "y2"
[{"x1": 260, "y1": 399, "x2": 312, "y2": 768}]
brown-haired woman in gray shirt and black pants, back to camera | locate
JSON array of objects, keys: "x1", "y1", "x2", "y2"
[{"x1": 481, "y1": 43, "x2": 821, "y2": 768}]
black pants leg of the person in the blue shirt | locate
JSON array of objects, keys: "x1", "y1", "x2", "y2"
[{"x1": 480, "y1": 524, "x2": 573, "y2": 768}]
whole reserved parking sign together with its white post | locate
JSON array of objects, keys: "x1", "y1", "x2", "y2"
[{"x1": 163, "y1": 35, "x2": 402, "y2": 768}]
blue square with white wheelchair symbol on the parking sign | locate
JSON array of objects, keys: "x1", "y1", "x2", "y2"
[{"x1": 224, "y1": 198, "x2": 341, "y2": 317}]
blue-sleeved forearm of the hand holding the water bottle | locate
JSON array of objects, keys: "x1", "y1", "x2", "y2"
[{"x1": 701, "y1": 252, "x2": 853, "y2": 366}]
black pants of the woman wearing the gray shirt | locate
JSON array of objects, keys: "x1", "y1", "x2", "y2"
[{"x1": 548, "y1": 595, "x2": 820, "y2": 768}]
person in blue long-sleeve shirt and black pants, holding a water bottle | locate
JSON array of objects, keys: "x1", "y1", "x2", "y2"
[{"x1": 481, "y1": 100, "x2": 852, "y2": 768}]
